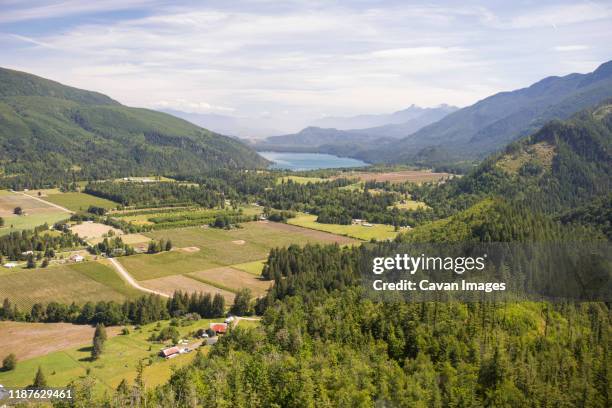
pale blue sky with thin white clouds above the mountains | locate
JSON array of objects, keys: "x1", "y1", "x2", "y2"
[{"x1": 0, "y1": 0, "x2": 612, "y2": 131}]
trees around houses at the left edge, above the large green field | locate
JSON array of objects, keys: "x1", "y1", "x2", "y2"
[{"x1": 0, "y1": 224, "x2": 85, "y2": 261}]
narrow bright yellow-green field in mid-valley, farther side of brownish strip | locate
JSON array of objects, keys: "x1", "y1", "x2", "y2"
[{"x1": 287, "y1": 214, "x2": 398, "y2": 241}]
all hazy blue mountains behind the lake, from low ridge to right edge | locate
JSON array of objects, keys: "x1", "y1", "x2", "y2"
[{"x1": 255, "y1": 61, "x2": 612, "y2": 166}]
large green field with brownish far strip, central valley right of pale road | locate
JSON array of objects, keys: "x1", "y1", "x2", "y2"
[{"x1": 121, "y1": 222, "x2": 355, "y2": 280}]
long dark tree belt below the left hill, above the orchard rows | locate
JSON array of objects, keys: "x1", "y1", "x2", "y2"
[{"x1": 85, "y1": 181, "x2": 225, "y2": 208}]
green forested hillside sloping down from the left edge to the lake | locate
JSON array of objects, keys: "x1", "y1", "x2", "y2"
[{"x1": 0, "y1": 68, "x2": 266, "y2": 188}]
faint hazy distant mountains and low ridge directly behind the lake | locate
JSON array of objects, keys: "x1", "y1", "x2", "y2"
[{"x1": 255, "y1": 105, "x2": 458, "y2": 156}]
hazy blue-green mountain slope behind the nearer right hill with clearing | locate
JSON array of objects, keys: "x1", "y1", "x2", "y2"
[{"x1": 358, "y1": 61, "x2": 612, "y2": 164}]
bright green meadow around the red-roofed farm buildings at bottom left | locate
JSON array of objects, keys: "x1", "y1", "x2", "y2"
[{"x1": 0, "y1": 319, "x2": 227, "y2": 395}]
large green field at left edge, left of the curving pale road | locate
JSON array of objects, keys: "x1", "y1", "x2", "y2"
[{"x1": 0, "y1": 262, "x2": 141, "y2": 310}]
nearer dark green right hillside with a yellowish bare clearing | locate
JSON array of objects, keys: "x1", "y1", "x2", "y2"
[{"x1": 415, "y1": 102, "x2": 612, "y2": 219}]
